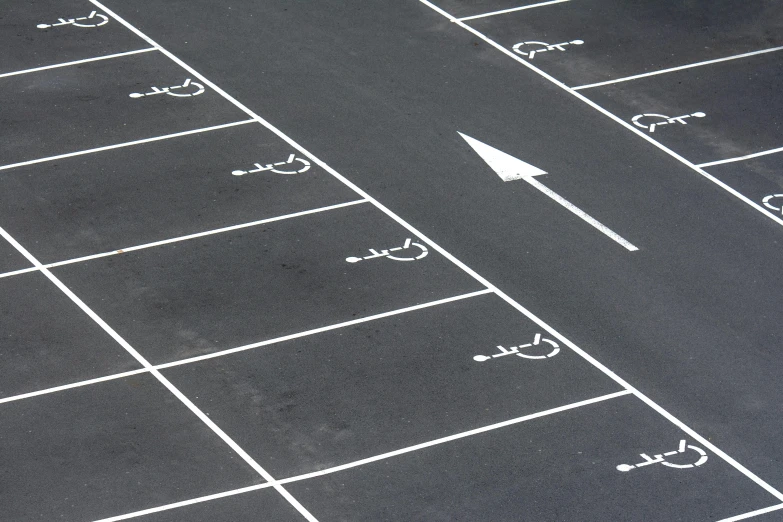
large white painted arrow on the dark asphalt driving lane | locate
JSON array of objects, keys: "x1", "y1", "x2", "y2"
[{"x1": 459, "y1": 132, "x2": 639, "y2": 252}]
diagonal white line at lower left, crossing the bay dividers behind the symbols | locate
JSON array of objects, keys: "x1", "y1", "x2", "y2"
[{"x1": 0, "y1": 219, "x2": 318, "y2": 522}]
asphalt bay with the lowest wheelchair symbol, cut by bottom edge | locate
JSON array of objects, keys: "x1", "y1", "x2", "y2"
[{"x1": 286, "y1": 396, "x2": 771, "y2": 522}]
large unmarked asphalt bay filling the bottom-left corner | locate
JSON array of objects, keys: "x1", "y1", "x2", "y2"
[{"x1": 0, "y1": 375, "x2": 261, "y2": 521}]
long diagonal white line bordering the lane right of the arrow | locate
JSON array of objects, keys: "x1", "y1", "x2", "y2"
[{"x1": 419, "y1": 0, "x2": 783, "y2": 231}]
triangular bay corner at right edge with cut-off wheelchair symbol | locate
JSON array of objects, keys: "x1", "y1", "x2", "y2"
[{"x1": 704, "y1": 152, "x2": 783, "y2": 217}]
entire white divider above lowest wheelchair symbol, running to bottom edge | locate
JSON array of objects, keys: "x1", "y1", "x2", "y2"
[{"x1": 95, "y1": 390, "x2": 631, "y2": 522}]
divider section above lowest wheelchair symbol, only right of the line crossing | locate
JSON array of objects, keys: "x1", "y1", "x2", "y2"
[{"x1": 278, "y1": 390, "x2": 631, "y2": 484}]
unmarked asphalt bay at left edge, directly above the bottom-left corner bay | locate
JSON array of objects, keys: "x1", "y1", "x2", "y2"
[{"x1": 0, "y1": 272, "x2": 140, "y2": 397}]
